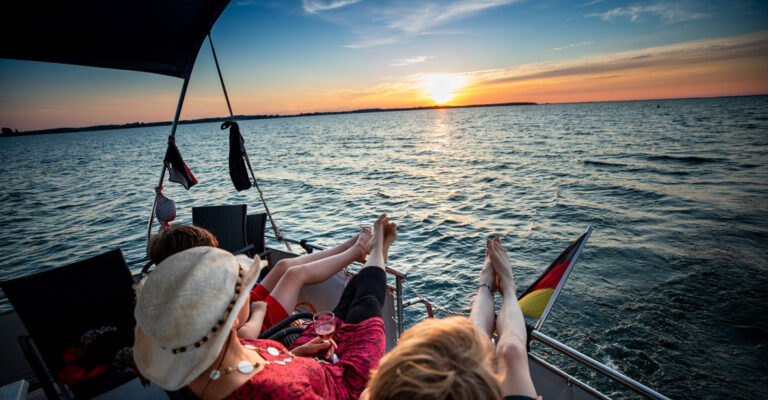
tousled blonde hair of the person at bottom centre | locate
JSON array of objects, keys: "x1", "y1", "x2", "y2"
[{"x1": 368, "y1": 317, "x2": 502, "y2": 400}]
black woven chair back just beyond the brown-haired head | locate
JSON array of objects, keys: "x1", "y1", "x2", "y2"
[{"x1": 192, "y1": 204, "x2": 253, "y2": 254}]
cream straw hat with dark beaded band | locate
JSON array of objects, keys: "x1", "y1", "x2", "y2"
[{"x1": 133, "y1": 247, "x2": 262, "y2": 390}]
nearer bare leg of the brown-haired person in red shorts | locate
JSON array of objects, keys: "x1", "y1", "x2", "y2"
[{"x1": 272, "y1": 228, "x2": 371, "y2": 314}]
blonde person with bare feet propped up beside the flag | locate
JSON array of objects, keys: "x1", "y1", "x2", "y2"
[{"x1": 363, "y1": 238, "x2": 536, "y2": 400}]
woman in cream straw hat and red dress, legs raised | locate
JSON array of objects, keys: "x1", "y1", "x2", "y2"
[{"x1": 134, "y1": 215, "x2": 397, "y2": 399}]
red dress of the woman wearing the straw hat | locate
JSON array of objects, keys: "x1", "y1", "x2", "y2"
[{"x1": 227, "y1": 317, "x2": 385, "y2": 399}]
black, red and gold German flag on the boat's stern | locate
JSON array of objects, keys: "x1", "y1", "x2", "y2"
[{"x1": 517, "y1": 226, "x2": 592, "y2": 318}]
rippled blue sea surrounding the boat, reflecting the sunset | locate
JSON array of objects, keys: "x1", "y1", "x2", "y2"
[{"x1": 0, "y1": 96, "x2": 768, "y2": 399}]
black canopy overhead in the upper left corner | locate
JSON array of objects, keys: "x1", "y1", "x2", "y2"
[{"x1": 0, "y1": 0, "x2": 229, "y2": 79}]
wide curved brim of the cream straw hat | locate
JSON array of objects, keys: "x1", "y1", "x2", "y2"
[{"x1": 133, "y1": 252, "x2": 263, "y2": 390}]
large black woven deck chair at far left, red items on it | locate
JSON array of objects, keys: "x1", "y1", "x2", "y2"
[{"x1": 0, "y1": 249, "x2": 136, "y2": 399}]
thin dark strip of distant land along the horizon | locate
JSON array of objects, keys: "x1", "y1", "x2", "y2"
[{"x1": 0, "y1": 102, "x2": 537, "y2": 137}]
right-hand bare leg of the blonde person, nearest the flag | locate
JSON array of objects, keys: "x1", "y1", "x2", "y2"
[{"x1": 488, "y1": 238, "x2": 536, "y2": 397}]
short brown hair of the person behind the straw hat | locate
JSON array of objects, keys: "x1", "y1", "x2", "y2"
[{"x1": 147, "y1": 225, "x2": 219, "y2": 265}]
